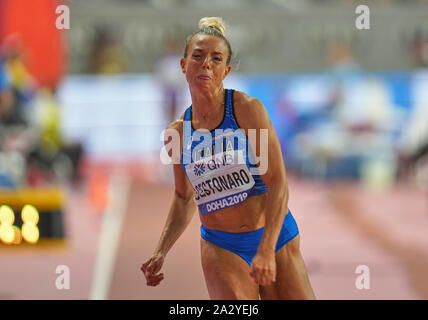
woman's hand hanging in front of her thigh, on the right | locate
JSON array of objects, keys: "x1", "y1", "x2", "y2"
[{"x1": 250, "y1": 251, "x2": 276, "y2": 286}]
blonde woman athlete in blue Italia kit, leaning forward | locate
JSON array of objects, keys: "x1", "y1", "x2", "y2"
[{"x1": 141, "y1": 17, "x2": 315, "y2": 300}]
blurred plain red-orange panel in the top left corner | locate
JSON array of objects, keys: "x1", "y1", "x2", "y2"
[{"x1": 0, "y1": 0, "x2": 67, "y2": 90}]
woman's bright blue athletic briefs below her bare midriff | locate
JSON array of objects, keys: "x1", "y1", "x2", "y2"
[{"x1": 201, "y1": 211, "x2": 299, "y2": 265}]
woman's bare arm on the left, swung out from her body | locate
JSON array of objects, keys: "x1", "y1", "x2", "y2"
[{"x1": 141, "y1": 120, "x2": 196, "y2": 286}]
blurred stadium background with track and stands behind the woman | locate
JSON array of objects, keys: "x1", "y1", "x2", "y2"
[{"x1": 0, "y1": 0, "x2": 428, "y2": 299}]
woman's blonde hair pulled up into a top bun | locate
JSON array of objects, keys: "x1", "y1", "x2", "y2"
[{"x1": 183, "y1": 17, "x2": 232, "y2": 65}]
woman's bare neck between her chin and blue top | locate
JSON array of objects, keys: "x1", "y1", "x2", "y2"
[{"x1": 190, "y1": 86, "x2": 225, "y2": 123}]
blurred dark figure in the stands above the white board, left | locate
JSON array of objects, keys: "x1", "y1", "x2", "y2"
[{"x1": 89, "y1": 26, "x2": 127, "y2": 74}]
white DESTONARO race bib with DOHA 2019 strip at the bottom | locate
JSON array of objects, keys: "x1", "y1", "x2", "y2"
[{"x1": 186, "y1": 150, "x2": 255, "y2": 214}]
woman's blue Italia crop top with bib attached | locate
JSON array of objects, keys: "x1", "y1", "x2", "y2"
[{"x1": 180, "y1": 89, "x2": 267, "y2": 214}]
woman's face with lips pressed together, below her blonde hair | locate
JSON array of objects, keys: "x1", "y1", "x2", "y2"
[{"x1": 180, "y1": 34, "x2": 231, "y2": 90}]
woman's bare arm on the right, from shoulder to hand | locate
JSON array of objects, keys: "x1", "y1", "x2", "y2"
[{"x1": 236, "y1": 92, "x2": 288, "y2": 285}]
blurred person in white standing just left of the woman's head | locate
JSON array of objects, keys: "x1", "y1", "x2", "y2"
[{"x1": 155, "y1": 36, "x2": 186, "y2": 123}]
